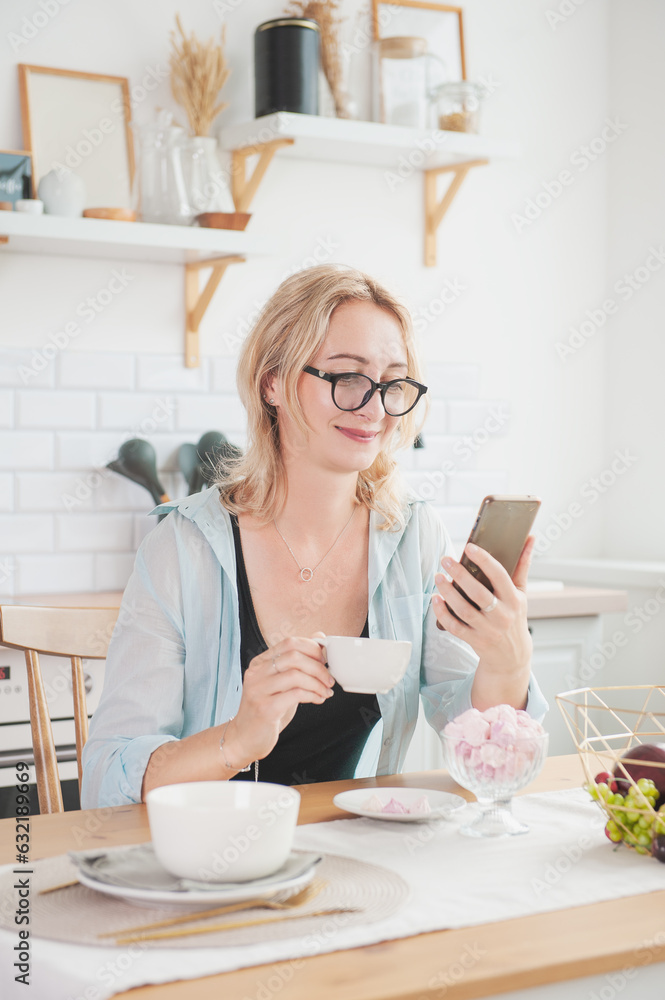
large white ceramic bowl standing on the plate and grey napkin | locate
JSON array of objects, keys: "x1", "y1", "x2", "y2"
[{"x1": 146, "y1": 781, "x2": 300, "y2": 882}]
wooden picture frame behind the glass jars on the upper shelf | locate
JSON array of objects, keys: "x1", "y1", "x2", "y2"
[{"x1": 372, "y1": 0, "x2": 466, "y2": 80}]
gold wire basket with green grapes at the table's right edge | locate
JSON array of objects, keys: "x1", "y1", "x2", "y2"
[{"x1": 556, "y1": 684, "x2": 665, "y2": 854}]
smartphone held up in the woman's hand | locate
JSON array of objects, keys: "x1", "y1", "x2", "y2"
[{"x1": 446, "y1": 494, "x2": 541, "y2": 620}]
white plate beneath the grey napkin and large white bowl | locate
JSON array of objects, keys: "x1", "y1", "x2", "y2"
[{"x1": 78, "y1": 845, "x2": 319, "y2": 906}]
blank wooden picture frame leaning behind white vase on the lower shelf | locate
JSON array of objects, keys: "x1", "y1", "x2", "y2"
[{"x1": 18, "y1": 63, "x2": 134, "y2": 208}]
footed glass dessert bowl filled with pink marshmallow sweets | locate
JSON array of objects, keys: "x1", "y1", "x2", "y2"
[{"x1": 440, "y1": 705, "x2": 549, "y2": 837}]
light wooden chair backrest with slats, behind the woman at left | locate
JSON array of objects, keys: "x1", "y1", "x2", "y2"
[{"x1": 0, "y1": 604, "x2": 119, "y2": 813}]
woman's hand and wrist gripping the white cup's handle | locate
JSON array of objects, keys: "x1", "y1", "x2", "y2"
[{"x1": 224, "y1": 633, "x2": 335, "y2": 768}]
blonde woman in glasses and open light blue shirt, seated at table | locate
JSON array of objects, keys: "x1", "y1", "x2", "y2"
[{"x1": 82, "y1": 265, "x2": 547, "y2": 807}]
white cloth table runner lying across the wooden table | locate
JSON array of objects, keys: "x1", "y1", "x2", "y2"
[{"x1": 0, "y1": 789, "x2": 665, "y2": 1000}]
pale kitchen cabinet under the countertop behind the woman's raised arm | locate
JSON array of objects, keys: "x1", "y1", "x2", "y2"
[{"x1": 403, "y1": 615, "x2": 602, "y2": 772}]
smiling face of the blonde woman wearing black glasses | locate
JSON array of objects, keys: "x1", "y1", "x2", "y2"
[{"x1": 276, "y1": 301, "x2": 408, "y2": 473}]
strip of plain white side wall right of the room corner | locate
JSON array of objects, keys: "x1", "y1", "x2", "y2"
[{"x1": 599, "y1": 0, "x2": 665, "y2": 560}]
